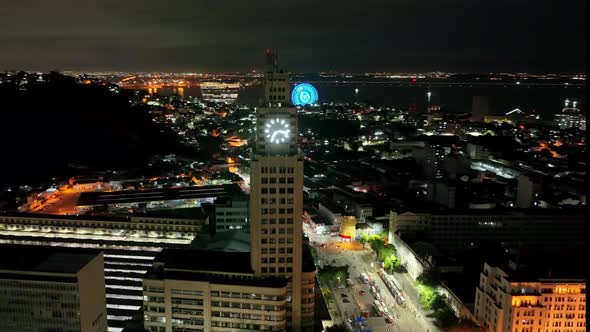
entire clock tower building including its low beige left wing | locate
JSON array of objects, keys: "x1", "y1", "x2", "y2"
[{"x1": 144, "y1": 51, "x2": 315, "y2": 332}]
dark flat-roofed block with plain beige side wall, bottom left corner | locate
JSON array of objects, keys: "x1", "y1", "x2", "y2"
[{"x1": 0, "y1": 245, "x2": 107, "y2": 332}]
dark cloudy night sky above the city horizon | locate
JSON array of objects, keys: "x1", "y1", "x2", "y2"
[{"x1": 0, "y1": 0, "x2": 586, "y2": 72}]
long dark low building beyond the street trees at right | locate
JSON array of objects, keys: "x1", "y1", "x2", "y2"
[{"x1": 389, "y1": 209, "x2": 586, "y2": 252}]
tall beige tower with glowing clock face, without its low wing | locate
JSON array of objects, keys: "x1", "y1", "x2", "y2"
[{"x1": 250, "y1": 50, "x2": 314, "y2": 331}]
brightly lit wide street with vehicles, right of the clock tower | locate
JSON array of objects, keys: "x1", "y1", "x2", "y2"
[{"x1": 304, "y1": 223, "x2": 439, "y2": 332}]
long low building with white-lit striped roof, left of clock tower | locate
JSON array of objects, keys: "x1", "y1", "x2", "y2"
[{"x1": 0, "y1": 214, "x2": 207, "y2": 332}]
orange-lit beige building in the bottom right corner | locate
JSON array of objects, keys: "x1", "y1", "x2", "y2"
[{"x1": 475, "y1": 264, "x2": 586, "y2": 332}]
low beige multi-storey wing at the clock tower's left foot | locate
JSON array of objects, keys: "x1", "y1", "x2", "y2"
[{"x1": 143, "y1": 249, "x2": 287, "y2": 332}]
